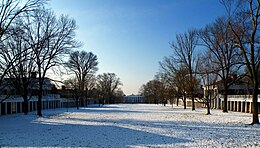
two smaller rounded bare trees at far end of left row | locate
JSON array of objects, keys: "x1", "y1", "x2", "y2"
[{"x1": 64, "y1": 50, "x2": 124, "y2": 108}]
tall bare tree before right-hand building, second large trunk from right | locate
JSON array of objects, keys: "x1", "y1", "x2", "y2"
[{"x1": 199, "y1": 17, "x2": 241, "y2": 112}]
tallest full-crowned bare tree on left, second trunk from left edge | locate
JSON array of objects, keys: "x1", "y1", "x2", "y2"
[{"x1": 24, "y1": 10, "x2": 78, "y2": 116}]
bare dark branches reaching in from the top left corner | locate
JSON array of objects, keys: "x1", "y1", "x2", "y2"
[{"x1": 0, "y1": 0, "x2": 46, "y2": 92}]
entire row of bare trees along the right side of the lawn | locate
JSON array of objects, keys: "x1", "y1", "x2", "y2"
[{"x1": 141, "y1": 0, "x2": 260, "y2": 124}]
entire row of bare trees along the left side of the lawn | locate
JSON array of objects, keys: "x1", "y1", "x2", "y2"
[{"x1": 0, "y1": 0, "x2": 123, "y2": 116}]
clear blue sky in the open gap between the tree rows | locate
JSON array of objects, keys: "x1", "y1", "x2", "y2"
[{"x1": 48, "y1": 0, "x2": 225, "y2": 95}]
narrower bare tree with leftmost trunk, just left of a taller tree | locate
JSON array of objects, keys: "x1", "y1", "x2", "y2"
[{"x1": 2, "y1": 24, "x2": 36, "y2": 115}]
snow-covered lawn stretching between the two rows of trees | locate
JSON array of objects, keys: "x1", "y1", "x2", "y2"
[{"x1": 0, "y1": 104, "x2": 260, "y2": 148}]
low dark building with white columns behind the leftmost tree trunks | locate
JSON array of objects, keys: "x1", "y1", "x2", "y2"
[{"x1": 0, "y1": 78, "x2": 62, "y2": 115}]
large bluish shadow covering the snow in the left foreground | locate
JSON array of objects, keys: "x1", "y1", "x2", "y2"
[{"x1": 0, "y1": 118, "x2": 190, "y2": 147}]
